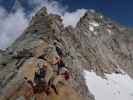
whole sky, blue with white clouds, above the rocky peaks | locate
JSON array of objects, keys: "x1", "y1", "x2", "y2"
[{"x1": 0, "y1": 0, "x2": 133, "y2": 49}]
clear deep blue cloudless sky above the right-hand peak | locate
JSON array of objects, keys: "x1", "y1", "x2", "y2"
[{"x1": 60, "y1": 0, "x2": 133, "y2": 27}]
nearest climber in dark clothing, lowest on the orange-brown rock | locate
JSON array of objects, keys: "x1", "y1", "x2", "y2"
[{"x1": 24, "y1": 56, "x2": 52, "y2": 95}]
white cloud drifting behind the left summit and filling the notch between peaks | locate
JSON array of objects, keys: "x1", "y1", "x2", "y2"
[{"x1": 29, "y1": 0, "x2": 86, "y2": 27}]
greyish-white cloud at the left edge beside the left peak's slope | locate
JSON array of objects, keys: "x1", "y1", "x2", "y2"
[{"x1": 0, "y1": 7, "x2": 29, "y2": 49}]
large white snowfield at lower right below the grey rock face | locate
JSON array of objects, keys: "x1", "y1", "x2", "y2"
[{"x1": 84, "y1": 70, "x2": 133, "y2": 100}]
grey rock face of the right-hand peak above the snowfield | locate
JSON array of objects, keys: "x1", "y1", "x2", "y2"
[{"x1": 76, "y1": 12, "x2": 133, "y2": 77}]
